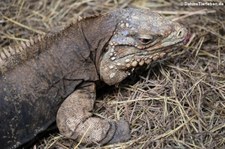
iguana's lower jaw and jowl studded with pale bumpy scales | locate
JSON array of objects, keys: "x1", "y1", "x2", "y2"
[{"x1": 99, "y1": 47, "x2": 174, "y2": 85}]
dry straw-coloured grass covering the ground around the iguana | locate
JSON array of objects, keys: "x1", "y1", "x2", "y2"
[{"x1": 0, "y1": 0, "x2": 225, "y2": 149}]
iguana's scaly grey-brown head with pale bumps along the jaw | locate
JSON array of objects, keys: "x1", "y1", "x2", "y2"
[{"x1": 99, "y1": 8, "x2": 188, "y2": 85}]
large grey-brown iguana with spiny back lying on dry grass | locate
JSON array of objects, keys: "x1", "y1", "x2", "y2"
[{"x1": 0, "y1": 8, "x2": 188, "y2": 149}]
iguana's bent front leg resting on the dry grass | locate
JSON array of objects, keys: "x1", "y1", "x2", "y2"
[{"x1": 56, "y1": 83, "x2": 130, "y2": 144}]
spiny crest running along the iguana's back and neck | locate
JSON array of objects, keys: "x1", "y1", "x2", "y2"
[{"x1": 0, "y1": 13, "x2": 104, "y2": 74}]
